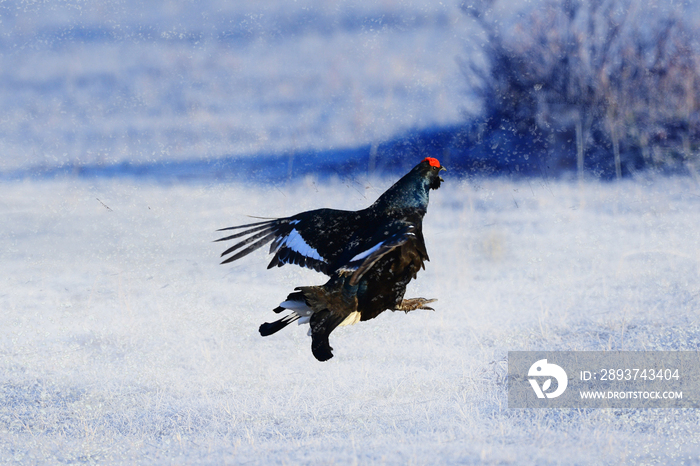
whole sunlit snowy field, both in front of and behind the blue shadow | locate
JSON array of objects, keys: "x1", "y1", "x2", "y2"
[{"x1": 0, "y1": 0, "x2": 700, "y2": 464}]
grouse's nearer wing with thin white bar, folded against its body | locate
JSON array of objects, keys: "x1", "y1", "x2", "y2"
[{"x1": 338, "y1": 220, "x2": 430, "y2": 285}]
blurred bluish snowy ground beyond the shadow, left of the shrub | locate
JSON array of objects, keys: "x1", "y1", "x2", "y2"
[{"x1": 0, "y1": 0, "x2": 470, "y2": 173}]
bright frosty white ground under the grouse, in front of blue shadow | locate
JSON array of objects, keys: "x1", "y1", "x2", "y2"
[{"x1": 0, "y1": 177, "x2": 700, "y2": 464}]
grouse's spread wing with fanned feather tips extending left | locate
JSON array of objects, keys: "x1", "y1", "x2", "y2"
[{"x1": 216, "y1": 209, "x2": 358, "y2": 275}]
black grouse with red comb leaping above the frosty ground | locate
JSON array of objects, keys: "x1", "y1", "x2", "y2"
[{"x1": 217, "y1": 157, "x2": 445, "y2": 361}]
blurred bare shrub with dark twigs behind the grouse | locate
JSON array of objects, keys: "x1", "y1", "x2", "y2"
[{"x1": 462, "y1": 0, "x2": 700, "y2": 177}]
